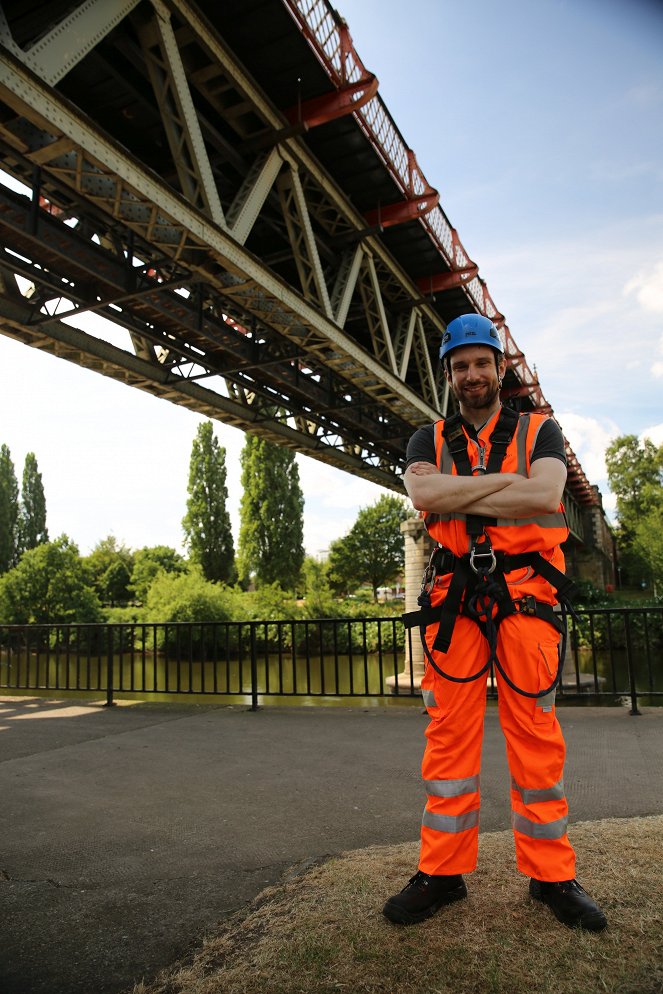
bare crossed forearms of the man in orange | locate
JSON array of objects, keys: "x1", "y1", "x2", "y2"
[{"x1": 404, "y1": 458, "x2": 566, "y2": 518}]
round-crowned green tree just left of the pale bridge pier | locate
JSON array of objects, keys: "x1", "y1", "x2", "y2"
[{"x1": 329, "y1": 494, "x2": 414, "y2": 601}]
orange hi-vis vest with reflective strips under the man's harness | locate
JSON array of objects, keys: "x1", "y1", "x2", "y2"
[{"x1": 424, "y1": 409, "x2": 569, "y2": 568}]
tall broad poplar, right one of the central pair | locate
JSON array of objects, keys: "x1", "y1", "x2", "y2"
[{"x1": 238, "y1": 435, "x2": 304, "y2": 590}]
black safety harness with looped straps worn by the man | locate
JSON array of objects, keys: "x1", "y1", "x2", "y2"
[{"x1": 403, "y1": 407, "x2": 574, "y2": 698}]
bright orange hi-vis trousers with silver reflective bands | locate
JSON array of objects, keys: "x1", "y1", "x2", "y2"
[{"x1": 419, "y1": 614, "x2": 575, "y2": 881}]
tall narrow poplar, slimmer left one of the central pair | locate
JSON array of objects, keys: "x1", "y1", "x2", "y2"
[{"x1": 182, "y1": 421, "x2": 235, "y2": 583}]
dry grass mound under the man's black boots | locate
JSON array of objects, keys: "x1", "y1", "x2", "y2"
[{"x1": 134, "y1": 816, "x2": 663, "y2": 994}]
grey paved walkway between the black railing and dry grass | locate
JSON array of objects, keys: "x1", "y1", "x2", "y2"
[{"x1": 0, "y1": 698, "x2": 663, "y2": 994}]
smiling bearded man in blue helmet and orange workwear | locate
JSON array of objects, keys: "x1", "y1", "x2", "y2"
[{"x1": 384, "y1": 314, "x2": 607, "y2": 931}]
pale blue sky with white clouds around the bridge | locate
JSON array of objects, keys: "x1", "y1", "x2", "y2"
[{"x1": 0, "y1": 0, "x2": 663, "y2": 555}]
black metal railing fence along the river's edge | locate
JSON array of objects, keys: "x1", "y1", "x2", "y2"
[{"x1": 0, "y1": 607, "x2": 663, "y2": 714}]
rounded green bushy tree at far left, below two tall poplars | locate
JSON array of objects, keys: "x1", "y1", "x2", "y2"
[{"x1": 0, "y1": 535, "x2": 102, "y2": 625}]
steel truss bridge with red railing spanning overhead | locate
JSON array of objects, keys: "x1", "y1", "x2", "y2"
[{"x1": 0, "y1": 0, "x2": 600, "y2": 556}]
